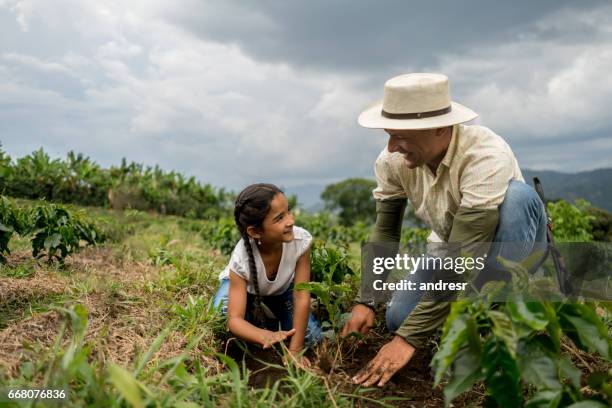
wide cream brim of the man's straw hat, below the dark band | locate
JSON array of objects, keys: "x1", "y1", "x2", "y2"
[{"x1": 357, "y1": 101, "x2": 478, "y2": 130}]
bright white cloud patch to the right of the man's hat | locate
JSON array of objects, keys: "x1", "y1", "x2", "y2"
[{"x1": 439, "y1": 5, "x2": 612, "y2": 143}]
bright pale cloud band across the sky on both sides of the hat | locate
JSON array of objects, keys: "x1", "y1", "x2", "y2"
[{"x1": 0, "y1": 0, "x2": 612, "y2": 193}]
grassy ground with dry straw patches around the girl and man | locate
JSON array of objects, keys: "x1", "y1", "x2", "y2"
[{"x1": 0, "y1": 200, "x2": 600, "y2": 408}]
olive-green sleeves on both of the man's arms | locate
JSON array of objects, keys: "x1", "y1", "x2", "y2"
[{"x1": 366, "y1": 199, "x2": 499, "y2": 348}]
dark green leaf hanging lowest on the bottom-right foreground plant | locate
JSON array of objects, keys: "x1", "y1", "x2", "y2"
[{"x1": 482, "y1": 337, "x2": 522, "y2": 408}]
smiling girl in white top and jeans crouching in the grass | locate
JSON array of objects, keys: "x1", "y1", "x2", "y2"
[{"x1": 214, "y1": 183, "x2": 322, "y2": 364}]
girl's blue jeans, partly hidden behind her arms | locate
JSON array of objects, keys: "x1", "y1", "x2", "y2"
[{"x1": 213, "y1": 279, "x2": 323, "y2": 347}]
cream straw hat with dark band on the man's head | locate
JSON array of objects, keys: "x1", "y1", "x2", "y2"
[{"x1": 358, "y1": 73, "x2": 478, "y2": 129}]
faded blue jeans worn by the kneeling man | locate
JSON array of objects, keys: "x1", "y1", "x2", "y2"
[{"x1": 386, "y1": 180, "x2": 547, "y2": 332}]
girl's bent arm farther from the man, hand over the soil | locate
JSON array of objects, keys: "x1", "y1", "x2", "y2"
[{"x1": 227, "y1": 271, "x2": 295, "y2": 348}]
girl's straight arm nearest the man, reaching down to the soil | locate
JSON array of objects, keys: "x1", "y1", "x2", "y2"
[{"x1": 289, "y1": 248, "x2": 310, "y2": 352}]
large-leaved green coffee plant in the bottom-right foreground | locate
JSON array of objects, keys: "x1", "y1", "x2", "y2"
[{"x1": 432, "y1": 282, "x2": 612, "y2": 407}]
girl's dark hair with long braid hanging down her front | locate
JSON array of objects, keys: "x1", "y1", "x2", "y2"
[{"x1": 234, "y1": 183, "x2": 282, "y2": 324}]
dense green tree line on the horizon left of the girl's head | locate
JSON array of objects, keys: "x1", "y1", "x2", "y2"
[{"x1": 0, "y1": 146, "x2": 232, "y2": 218}]
